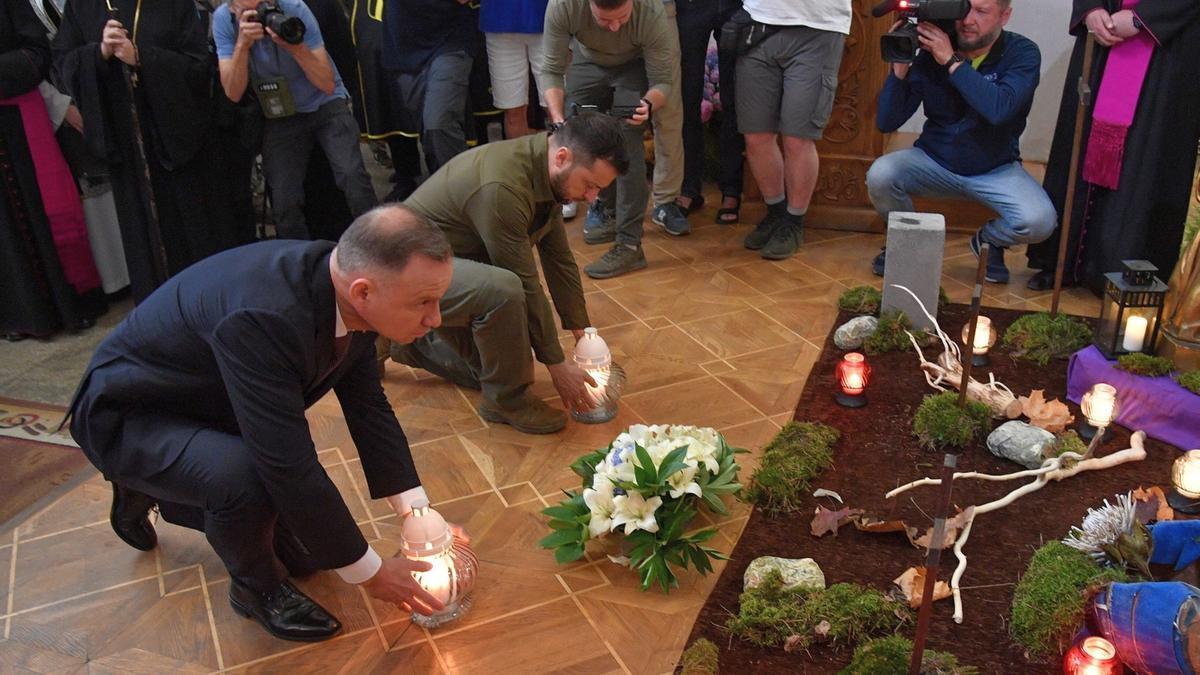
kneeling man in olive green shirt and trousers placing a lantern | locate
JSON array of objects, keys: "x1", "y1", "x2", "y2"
[{"x1": 391, "y1": 113, "x2": 629, "y2": 434}]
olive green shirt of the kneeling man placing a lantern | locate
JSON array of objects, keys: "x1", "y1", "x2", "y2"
[{"x1": 404, "y1": 133, "x2": 592, "y2": 365}]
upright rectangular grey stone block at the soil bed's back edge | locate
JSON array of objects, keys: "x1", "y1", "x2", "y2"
[{"x1": 881, "y1": 211, "x2": 946, "y2": 330}]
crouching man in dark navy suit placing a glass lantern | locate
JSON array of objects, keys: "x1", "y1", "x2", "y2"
[{"x1": 71, "y1": 204, "x2": 452, "y2": 640}]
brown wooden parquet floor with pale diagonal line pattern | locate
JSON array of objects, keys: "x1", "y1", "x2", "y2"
[{"x1": 0, "y1": 201, "x2": 1098, "y2": 675}]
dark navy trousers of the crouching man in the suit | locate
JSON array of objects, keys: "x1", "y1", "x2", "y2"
[{"x1": 106, "y1": 403, "x2": 298, "y2": 591}]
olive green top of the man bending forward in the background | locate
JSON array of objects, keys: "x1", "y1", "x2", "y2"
[{"x1": 541, "y1": 0, "x2": 679, "y2": 98}]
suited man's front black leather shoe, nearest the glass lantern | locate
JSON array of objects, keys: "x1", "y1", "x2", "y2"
[{"x1": 229, "y1": 579, "x2": 342, "y2": 643}]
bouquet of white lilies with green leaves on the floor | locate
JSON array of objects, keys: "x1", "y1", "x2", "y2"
[{"x1": 541, "y1": 424, "x2": 744, "y2": 592}]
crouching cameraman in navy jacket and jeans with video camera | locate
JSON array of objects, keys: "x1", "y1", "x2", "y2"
[{"x1": 866, "y1": 0, "x2": 1056, "y2": 283}]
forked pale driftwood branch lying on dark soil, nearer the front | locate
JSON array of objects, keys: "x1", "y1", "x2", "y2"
[{"x1": 886, "y1": 431, "x2": 1146, "y2": 623}]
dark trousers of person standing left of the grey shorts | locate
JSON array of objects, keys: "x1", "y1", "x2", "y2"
[{"x1": 676, "y1": 0, "x2": 745, "y2": 197}]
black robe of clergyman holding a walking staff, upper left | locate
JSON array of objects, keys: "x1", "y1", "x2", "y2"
[{"x1": 53, "y1": 0, "x2": 243, "y2": 301}]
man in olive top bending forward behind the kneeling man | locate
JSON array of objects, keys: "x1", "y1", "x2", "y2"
[{"x1": 541, "y1": 0, "x2": 686, "y2": 279}]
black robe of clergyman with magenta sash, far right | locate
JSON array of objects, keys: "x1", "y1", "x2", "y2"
[{"x1": 1027, "y1": 0, "x2": 1200, "y2": 292}]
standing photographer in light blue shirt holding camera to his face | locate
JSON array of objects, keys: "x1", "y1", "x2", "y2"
[{"x1": 212, "y1": 0, "x2": 377, "y2": 239}]
